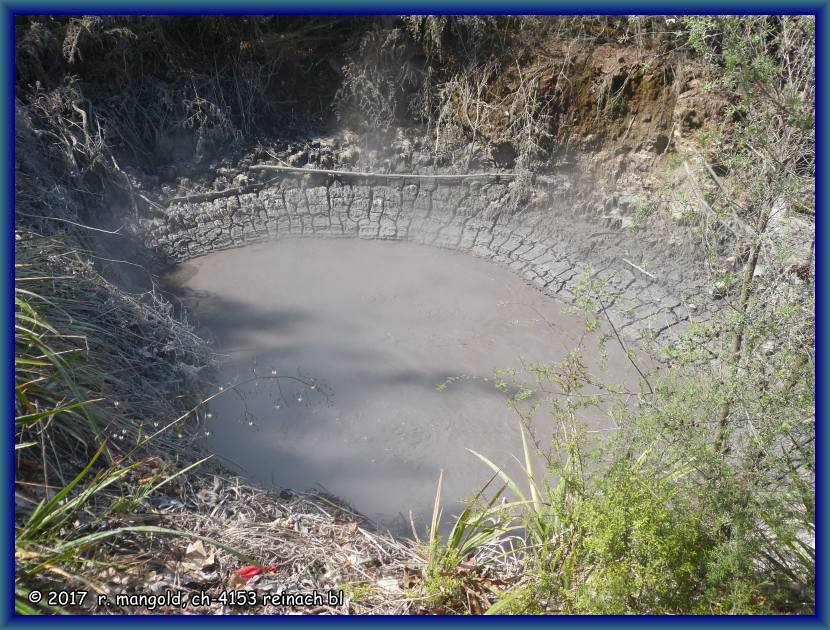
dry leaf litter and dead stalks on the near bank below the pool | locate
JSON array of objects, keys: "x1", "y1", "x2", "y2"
[{"x1": 68, "y1": 472, "x2": 422, "y2": 614}]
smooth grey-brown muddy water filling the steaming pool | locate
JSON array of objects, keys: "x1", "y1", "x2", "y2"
[{"x1": 167, "y1": 239, "x2": 632, "y2": 531}]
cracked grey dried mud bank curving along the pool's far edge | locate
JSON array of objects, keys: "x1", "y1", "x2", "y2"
[{"x1": 136, "y1": 174, "x2": 706, "y2": 348}]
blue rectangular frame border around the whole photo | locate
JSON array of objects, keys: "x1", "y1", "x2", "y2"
[{"x1": 0, "y1": 0, "x2": 830, "y2": 628}]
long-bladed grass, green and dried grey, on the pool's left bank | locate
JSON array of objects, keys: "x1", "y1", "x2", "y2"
[{"x1": 14, "y1": 233, "x2": 247, "y2": 614}]
